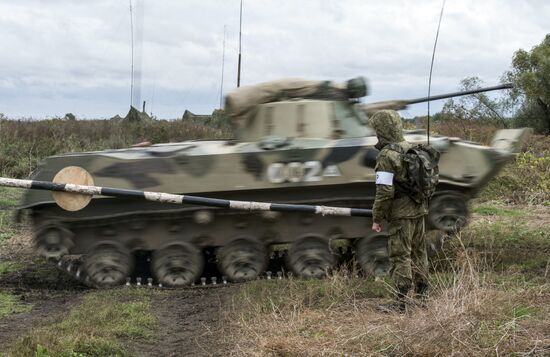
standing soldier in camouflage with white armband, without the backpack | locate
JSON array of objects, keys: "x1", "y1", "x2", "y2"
[{"x1": 370, "y1": 110, "x2": 428, "y2": 312}]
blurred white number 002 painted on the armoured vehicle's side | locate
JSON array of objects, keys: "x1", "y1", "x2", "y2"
[{"x1": 267, "y1": 161, "x2": 323, "y2": 183}]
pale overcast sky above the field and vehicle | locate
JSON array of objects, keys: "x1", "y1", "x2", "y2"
[{"x1": 0, "y1": 0, "x2": 550, "y2": 118}]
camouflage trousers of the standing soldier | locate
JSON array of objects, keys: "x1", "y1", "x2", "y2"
[{"x1": 388, "y1": 217, "x2": 428, "y2": 291}]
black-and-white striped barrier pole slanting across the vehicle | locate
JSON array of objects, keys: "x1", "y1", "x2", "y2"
[{"x1": 0, "y1": 173, "x2": 372, "y2": 217}]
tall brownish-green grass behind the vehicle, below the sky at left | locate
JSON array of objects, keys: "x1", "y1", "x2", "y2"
[{"x1": 0, "y1": 119, "x2": 231, "y2": 178}]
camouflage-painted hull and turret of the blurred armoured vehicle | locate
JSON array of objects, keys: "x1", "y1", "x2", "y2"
[{"x1": 21, "y1": 77, "x2": 523, "y2": 284}]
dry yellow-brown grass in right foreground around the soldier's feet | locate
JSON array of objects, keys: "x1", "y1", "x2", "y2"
[{"x1": 226, "y1": 238, "x2": 550, "y2": 356}]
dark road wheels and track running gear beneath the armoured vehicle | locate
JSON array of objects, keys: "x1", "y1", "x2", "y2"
[{"x1": 34, "y1": 191, "x2": 468, "y2": 287}]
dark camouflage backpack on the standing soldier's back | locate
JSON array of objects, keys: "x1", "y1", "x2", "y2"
[{"x1": 389, "y1": 144, "x2": 440, "y2": 203}]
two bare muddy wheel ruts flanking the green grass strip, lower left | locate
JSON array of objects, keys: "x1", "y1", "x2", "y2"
[{"x1": 0, "y1": 271, "x2": 233, "y2": 356}]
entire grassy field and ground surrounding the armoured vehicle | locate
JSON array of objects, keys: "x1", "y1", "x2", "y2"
[{"x1": 0, "y1": 120, "x2": 550, "y2": 357}]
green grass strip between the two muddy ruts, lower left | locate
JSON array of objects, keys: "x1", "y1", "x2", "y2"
[{"x1": 9, "y1": 289, "x2": 160, "y2": 356}]
